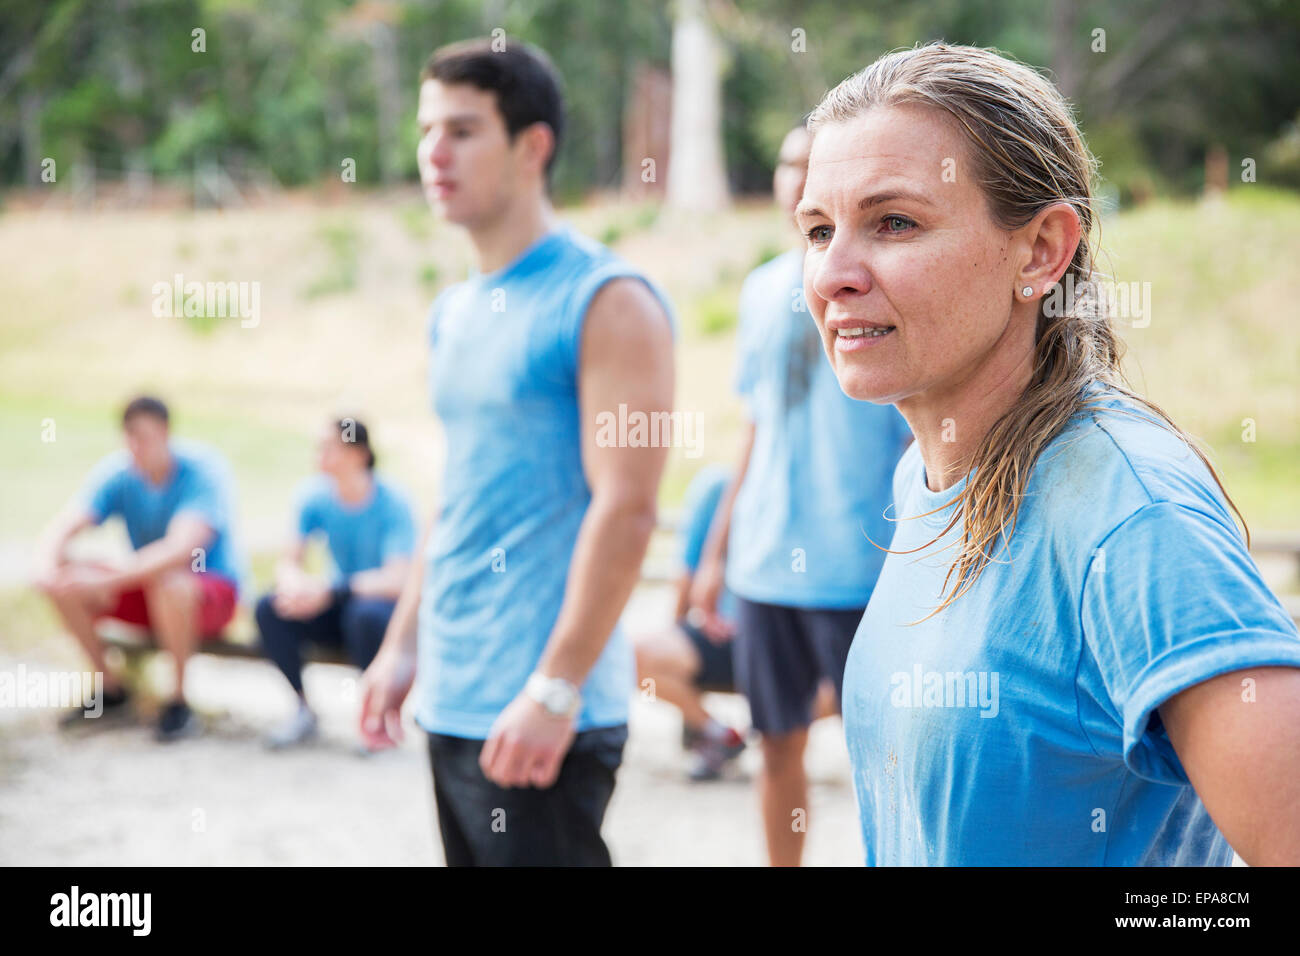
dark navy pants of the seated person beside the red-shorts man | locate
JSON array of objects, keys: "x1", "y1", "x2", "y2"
[{"x1": 256, "y1": 594, "x2": 397, "y2": 693}]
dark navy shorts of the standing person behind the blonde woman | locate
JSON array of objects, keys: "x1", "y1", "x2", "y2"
[{"x1": 735, "y1": 598, "x2": 865, "y2": 735}]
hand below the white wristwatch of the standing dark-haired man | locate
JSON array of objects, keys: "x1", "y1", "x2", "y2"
[{"x1": 478, "y1": 693, "x2": 573, "y2": 790}]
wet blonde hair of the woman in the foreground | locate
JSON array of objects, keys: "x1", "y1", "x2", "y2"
[{"x1": 809, "y1": 43, "x2": 1249, "y2": 614}]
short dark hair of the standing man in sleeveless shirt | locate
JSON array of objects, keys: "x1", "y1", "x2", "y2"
[{"x1": 420, "y1": 38, "x2": 564, "y2": 181}]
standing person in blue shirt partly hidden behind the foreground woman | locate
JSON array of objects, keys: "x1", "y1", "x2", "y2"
[{"x1": 693, "y1": 125, "x2": 911, "y2": 866}]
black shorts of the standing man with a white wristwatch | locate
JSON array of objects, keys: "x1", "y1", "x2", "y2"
[{"x1": 429, "y1": 724, "x2": 628, "y2": 866}]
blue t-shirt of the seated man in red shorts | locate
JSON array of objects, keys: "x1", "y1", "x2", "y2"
[{"x1": 82, "y1": 438, "x2": 244, "y2": 588}]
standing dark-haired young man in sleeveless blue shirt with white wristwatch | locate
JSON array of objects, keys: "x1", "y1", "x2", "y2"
[{"x1": 361, "y1": 40, "x2": 673, "y2": 865}]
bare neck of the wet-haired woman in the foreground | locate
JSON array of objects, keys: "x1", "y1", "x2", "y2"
[{"x1": 898, "y1": 323, "x2": 1034, "y2": 492}]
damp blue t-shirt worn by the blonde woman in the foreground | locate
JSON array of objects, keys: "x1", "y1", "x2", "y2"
[{"x1": 844, "y1": 390, "x2": 1300, "y2": 866}]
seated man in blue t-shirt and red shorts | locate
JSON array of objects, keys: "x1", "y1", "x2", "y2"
[{"x1": 33, "y1": 395, "x2": 243, "y2": 740}]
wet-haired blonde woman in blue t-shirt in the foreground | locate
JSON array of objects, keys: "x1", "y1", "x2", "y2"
[{"x1": 798, "y1": 44, "x2": 1300, "y2": 866}]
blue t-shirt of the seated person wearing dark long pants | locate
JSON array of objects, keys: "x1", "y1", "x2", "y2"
[{"x1": 298, "y1": 475, "x2": 415, "y2": 583}]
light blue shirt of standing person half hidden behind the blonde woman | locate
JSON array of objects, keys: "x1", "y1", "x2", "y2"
[{"x1": 727, "y1": 250, "x2": 911, "y2": 609}]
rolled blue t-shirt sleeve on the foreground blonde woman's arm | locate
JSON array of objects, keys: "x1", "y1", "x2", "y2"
[{"x1": 1082, "y1": 502, "x2": 1300, "y2": 784}]
